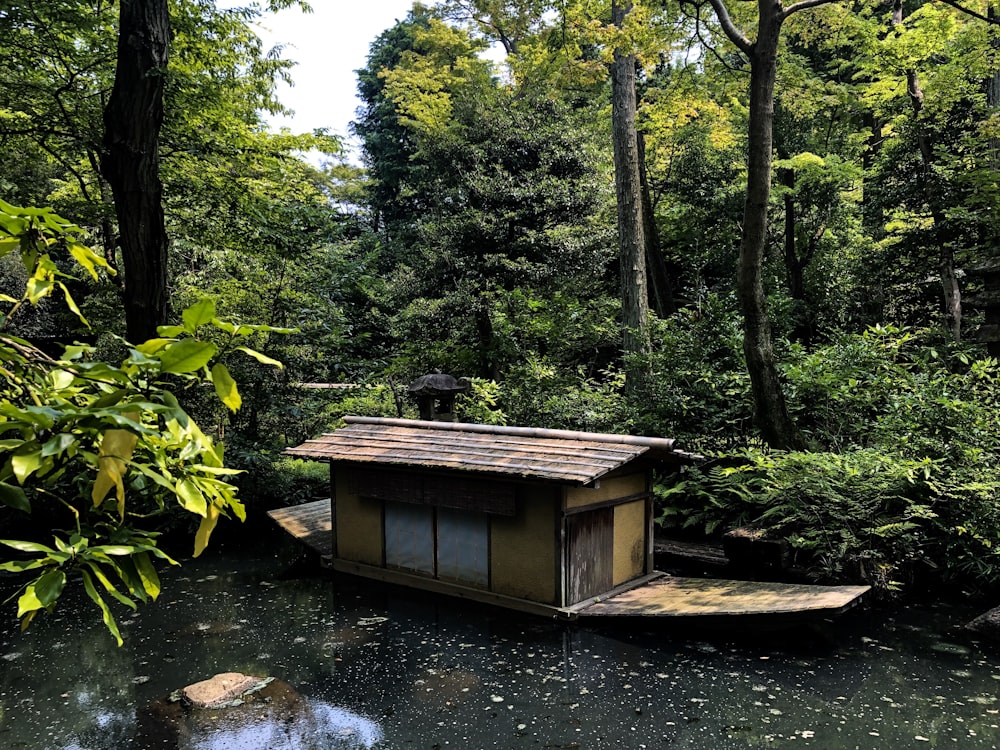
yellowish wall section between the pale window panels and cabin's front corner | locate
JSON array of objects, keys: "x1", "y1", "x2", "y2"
[{"x1": 490, "y1": 487, "x2": 560, "y2": 604}]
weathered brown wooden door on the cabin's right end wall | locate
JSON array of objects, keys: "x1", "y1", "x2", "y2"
[{"x1": 566, "y1": 508, "x2": 615, "y2": 605}]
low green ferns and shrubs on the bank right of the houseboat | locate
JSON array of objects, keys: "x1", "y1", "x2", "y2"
[{"x1": 658, "y1": 328, "x2": 1000, "y2": 589}]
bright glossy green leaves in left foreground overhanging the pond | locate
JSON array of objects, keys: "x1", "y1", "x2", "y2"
[{"x1": 0, "y1": 203, "x2": 280, "y2": 644}]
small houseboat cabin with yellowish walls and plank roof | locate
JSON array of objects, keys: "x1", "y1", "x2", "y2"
[{"x1": 287, "y1": 417, "x2": 691, "y2": 614}]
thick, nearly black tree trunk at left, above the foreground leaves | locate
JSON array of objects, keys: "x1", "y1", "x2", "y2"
[{"x1": 101, "y1": 0, "x2": 170, "y2": 342}]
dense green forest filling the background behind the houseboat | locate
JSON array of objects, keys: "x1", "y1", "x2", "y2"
[{"x1": 0, "y1": 0, "x2": 1000, "y2": 640}]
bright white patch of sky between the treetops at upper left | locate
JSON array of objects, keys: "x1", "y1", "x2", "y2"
[{"x1": 250, "y1": 0, "x2": 422, "y2": 152}]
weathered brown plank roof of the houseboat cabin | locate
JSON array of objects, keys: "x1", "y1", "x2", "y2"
[{"x1": 285, "y1": 417, "x2": 688, "y2": 485}]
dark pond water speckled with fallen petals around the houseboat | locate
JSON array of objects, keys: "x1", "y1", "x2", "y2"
[{"x1": 0, "y1": 535, "x2": 1000, "y2": 750}]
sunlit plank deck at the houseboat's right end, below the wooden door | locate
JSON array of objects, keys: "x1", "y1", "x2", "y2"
[{"x1": 578, "y1": 576, "x2": 869, "y2": 619}]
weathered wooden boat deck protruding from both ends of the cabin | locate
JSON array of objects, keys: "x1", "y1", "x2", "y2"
[{"x1": 268, "y1": 500, "x2": 869, "y2": 627}]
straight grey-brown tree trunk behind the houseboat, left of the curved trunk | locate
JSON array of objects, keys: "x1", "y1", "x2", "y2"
[{"x1": 611, "y1": 0, "x2": 650, "y2": 392}]
